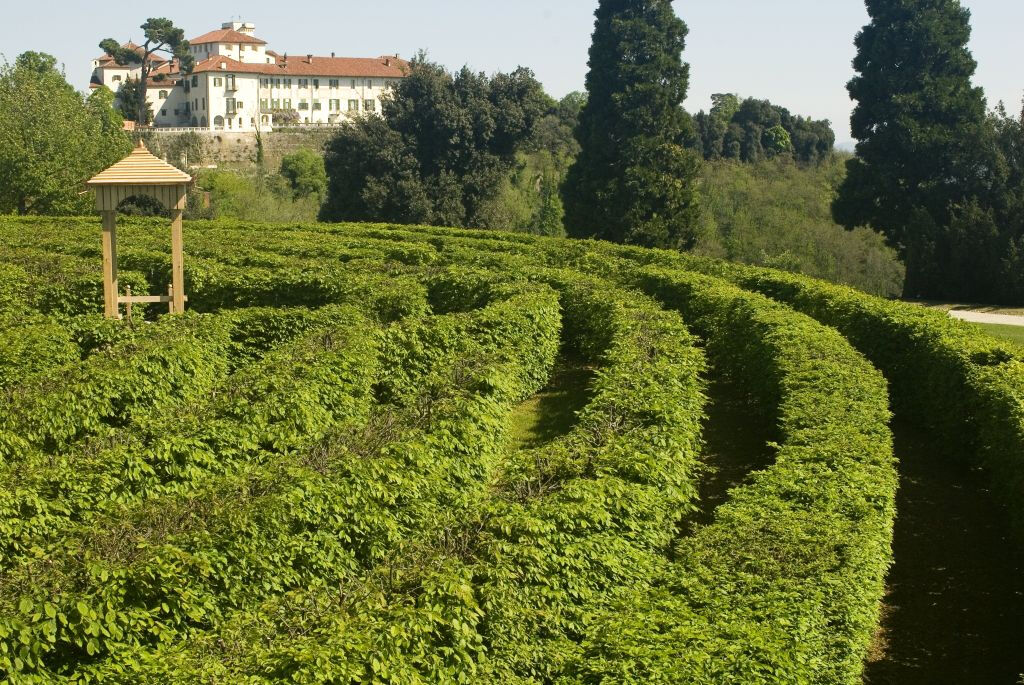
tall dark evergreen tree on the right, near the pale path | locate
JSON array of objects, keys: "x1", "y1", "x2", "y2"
[{"x1": 833, "y1": 0, "x2": 1000, "y2": 296}]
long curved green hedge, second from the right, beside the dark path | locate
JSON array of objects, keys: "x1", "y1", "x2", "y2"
[{"x1": 575, "y1": 268, "x2": 897, "y2": 685}]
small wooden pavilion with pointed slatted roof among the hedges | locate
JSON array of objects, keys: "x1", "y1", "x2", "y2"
[{"x1": 86, "y1": 140, "x2": 193, "y2": 318}]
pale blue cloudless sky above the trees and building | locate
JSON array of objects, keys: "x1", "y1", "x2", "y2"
[{"x1": 0, "y1": 0, "x2": 1024, "y2": 141}]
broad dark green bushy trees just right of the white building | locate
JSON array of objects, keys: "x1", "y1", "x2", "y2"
[{"x1": 321, "y1": 54, "x2": 555, "y2": 227}]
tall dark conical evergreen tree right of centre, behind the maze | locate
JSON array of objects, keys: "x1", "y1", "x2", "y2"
[{"x1": 563, "y1": 0, "x2": 700, "y2": 248}]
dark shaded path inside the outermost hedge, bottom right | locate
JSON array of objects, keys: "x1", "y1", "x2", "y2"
[{"x1": 864, "y1": 422, "x2": 1024, "y2": 685}]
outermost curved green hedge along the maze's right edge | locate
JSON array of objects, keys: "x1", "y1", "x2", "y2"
[{"x1": 716, "y1": 267, "x2": 1024, "y2": 541}]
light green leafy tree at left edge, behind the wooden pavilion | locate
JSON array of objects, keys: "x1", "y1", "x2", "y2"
[{"x1": 0, "y1": 52, "x2": 131, "y2": 214}]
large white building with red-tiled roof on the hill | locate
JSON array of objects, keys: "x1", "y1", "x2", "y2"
[{"x1": 90, "y1": 22, "x2": 409, "y2": 131}]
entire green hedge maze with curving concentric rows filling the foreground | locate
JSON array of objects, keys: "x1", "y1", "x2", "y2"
[{"x1": 0, "y1": 218, "x2": 1024, "y2": 685}]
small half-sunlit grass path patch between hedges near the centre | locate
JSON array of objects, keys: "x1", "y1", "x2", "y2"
[{"x1": 509, "y1": 356, "x2": 594, "y2": 449}]
